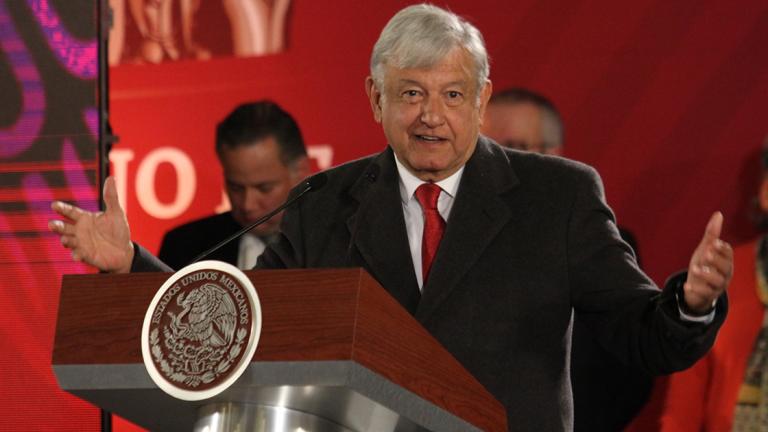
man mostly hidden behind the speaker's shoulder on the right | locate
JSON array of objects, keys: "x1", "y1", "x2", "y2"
[{"x1": 481, "y1": 88, "x2": 653, "y2": 432}]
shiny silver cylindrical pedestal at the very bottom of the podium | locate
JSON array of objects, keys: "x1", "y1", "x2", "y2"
[{"x1": 193, "y1": 403, "x2": 353, "y2": 432}]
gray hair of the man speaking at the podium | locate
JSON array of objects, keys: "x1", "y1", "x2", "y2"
[{"x1": 371, "y1": 4, "x2": 491, "y2": 97}]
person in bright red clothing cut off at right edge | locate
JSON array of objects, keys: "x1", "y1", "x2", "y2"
[{"x1": 661, "y1": 137, "x2": 768, "y2": 432}]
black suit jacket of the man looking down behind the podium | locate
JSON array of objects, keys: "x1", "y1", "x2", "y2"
[{"x1": 158, "y1": 212, "x2": 241, "y2": 270}]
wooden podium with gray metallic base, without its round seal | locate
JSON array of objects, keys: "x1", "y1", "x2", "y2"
[{"x1": 53, "y1": 269, "x2": 507, "y2": 432}]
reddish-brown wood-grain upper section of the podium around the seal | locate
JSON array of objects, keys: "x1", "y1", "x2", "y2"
[{"x1": 53, "y1": 269, "x2": 507, "y2": 431}]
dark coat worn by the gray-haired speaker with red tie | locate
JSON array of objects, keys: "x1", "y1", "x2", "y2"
[{"x1": 259, "y1": 138, "x2": 727, "y2": 431}]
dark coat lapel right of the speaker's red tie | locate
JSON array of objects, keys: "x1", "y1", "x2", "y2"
[{"x1": 416, "y1": 137, "x2": 518, "y2": 322}]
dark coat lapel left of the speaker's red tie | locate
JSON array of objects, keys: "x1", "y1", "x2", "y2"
[{"x1": 347, "y1": 147, "x2": 420, "y2": 314}]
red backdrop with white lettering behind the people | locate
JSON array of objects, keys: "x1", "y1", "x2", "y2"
[{"x1": 37, "y1": 0, "x2": 768, "y2": 428}]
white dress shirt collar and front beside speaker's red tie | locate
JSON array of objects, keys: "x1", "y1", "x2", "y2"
[{"x1": 395, "y1": 157, "x2": 464, "y2": 289}]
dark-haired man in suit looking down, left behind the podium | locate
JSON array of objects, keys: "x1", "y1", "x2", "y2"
[{"x1": 159, "y1": 101, "x2": 309, "y2": 269}]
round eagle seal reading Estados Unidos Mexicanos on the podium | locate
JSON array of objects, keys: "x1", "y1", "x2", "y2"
[{"x1": 141, "y1": 261, "x2": 261, "y2": 401}]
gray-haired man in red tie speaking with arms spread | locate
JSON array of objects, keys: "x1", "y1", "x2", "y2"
[{"x1": 50, "y1": 5, "x2": 732, "y2": 431}]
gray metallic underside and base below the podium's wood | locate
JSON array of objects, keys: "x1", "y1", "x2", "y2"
[{"x1": 54, "y1": 361, "x2": 479, "y2": 432}]
